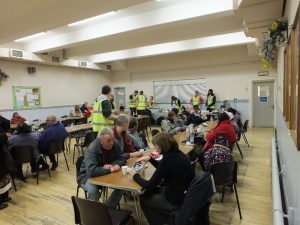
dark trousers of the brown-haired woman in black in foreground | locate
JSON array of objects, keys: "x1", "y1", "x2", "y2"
[{"x1": 140, "y1": 188, "x2": 178, "y2": 225}]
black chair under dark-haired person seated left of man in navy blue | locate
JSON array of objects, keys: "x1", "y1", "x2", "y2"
[{"x1": 10, "y1": 145, "x2": 51, "y2": 185}]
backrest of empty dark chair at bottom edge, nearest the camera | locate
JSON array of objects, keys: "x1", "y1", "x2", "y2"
[{"x1": 72, "y1": 196, "x2": 112, "y2": 225}]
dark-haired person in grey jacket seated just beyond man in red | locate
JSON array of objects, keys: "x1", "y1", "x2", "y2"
[{"x1": 127, "y1": 117, "x2": 149, "y2": 150}]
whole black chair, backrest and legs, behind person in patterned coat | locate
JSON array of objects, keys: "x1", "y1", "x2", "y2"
[{"x1": 210, "y1": 161, "x2": 242, "y2": 220}]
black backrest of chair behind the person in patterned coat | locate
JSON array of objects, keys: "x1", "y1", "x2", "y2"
[{"x1": 210, "y1": 161, "x2": 237, "y2": 186}]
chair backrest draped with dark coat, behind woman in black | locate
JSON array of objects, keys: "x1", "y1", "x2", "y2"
[{"x1": 168, "y1": 172, "x2": 213, "y2": 225}]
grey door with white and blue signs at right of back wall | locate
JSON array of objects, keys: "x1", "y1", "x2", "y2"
[{"x1": 253, "y1": 81, "x2": 274, "y2": 127}]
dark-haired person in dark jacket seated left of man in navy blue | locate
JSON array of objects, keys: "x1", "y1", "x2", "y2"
[{"x1": 8, "y1": 123, "x2": 41, "y2": 180}]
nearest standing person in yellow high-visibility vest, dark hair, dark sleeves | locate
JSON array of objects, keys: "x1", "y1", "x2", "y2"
[{"x1": 93, "y1": 85, "x2": 118, "y2": 134}]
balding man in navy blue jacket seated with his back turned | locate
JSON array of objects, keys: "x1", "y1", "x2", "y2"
[{"x1": 38, "y1": 115, "x2": 68, "y2": 170}]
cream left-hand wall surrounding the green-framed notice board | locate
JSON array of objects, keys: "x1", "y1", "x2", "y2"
[{"x1": 0, "y1": 60, "x2": 111, "y2": 109}]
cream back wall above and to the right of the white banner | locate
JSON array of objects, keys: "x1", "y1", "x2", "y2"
[{"x1": 113, "y1": 46, "x2": 276, "y2": 122}]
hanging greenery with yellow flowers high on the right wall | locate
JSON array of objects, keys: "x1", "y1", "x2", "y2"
[{"x1": 260, "y1": 20, "x2": 288, "y2": 70}]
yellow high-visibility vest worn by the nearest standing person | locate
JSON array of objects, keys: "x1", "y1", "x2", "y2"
[{"x1": 93, "y1": 95, "x2": 114, "y2": 132}]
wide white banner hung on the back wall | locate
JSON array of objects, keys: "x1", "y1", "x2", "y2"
[{"x1": 153, "y1": 78, "x2": 206, "y2": 104}]
